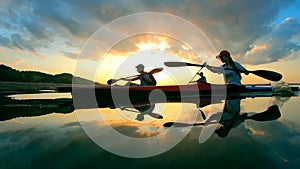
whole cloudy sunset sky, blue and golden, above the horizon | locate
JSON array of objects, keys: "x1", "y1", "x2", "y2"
[{"x1": 0, "y1": 0, "x2": 300, "y2": 83}]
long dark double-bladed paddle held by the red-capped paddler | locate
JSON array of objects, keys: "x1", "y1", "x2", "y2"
[{"x1": 165, "y1": 62, "x2": 282, "y2": 81}]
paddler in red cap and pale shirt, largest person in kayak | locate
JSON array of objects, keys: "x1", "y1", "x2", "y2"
[{"x1": 204, "y1": 50, "x2": 249, "y2": 90}]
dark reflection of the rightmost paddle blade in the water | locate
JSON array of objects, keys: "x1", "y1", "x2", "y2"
[{"x1": 247, "y1": 105, "x2": 281, "y2": 121}]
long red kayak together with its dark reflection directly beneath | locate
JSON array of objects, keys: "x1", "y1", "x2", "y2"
[{"x1": 58, "y1": 82, "x2": 299, "y2": 108}]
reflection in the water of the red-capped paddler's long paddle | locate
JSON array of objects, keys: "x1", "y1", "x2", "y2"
[{"x1": 163, "y1": 105, "x2": 281, "y2": 127}]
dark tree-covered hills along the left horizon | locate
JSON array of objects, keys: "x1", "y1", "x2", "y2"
[{"x1": 0, "y1": 65, "x2": 98, "y2": 84}]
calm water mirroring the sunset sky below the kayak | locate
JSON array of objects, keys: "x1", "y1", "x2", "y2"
[{"x1": 0, "y1": 92, "x2": 300, "y2": 169}]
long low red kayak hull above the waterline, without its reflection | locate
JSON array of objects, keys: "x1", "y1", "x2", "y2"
[{"x1": 58, "y1": 82, "x2": 299, "y2": 96}]
